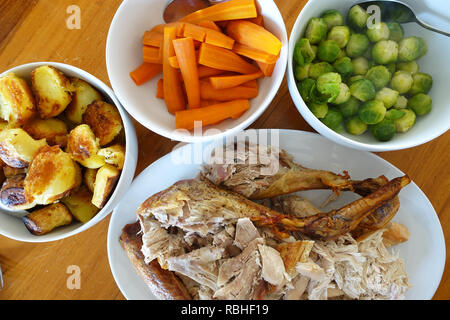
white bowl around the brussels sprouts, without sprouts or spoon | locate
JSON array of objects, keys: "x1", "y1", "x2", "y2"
[{"x1": 287, "y1": 0, "x2": 450, "y2": 151}]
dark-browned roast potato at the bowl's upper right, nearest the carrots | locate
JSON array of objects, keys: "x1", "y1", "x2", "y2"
[{"x1": 83, "y1": 101, "x2": 123, "y2": 146}]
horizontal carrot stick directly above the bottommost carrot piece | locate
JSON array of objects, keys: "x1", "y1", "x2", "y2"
[{"x1": 200, "y1": 81, "x2": 258, "y2": 101}]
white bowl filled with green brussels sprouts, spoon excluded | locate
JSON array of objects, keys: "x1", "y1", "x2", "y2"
[{"x1": 287, "y1": 0, "x2": 450, "y2": 151}]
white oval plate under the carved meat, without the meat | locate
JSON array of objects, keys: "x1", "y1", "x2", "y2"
[{"x1": 108, "y1": 130, "x2": 446, "y2": 300}]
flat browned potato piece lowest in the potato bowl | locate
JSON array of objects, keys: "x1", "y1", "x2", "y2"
[{"x1": 22, "y1": 202, "x2": 73, "y2": 236}]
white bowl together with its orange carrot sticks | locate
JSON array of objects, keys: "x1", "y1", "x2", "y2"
[{"x1": 106, "y1": 0, "x2": 288, "y2": 142}]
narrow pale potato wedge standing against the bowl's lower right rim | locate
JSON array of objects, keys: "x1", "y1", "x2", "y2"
[{"x1": 92, "y1": 164, "x2": 120, "y2": 209}]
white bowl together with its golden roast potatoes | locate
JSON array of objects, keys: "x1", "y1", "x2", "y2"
[{"x1": 0, "y1": 62, "x2": 137, "y2": 242}]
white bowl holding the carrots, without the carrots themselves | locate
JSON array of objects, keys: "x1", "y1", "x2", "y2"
[{"x1": 106, "y1": 0, "x2": 288, "y2": 142}]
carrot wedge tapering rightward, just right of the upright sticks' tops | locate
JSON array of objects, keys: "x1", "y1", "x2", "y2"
[{"x1": 198, "y1": 42, "x2": 258, "y2": 73}]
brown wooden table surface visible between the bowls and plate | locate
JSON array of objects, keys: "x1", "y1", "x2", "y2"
[{"x1": 0, "y1": 0, "x2": 450, "y2": 299}]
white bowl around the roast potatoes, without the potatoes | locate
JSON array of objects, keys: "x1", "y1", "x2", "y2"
[{"x1": 0, "y1": 62, "x2": 138, "y2": 242}]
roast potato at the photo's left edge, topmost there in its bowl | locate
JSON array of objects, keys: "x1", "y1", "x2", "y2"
[{"x1": 0, "y1": 73, "x2": 36, "y2": 127}]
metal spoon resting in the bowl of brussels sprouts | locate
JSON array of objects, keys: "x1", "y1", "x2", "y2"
[{"x1": 357, "y1": 0, "x2": 450, "y2": 37}]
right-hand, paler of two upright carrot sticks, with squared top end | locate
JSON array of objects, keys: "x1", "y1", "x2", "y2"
[{"x1": 173, "y1": 38, "x2": 200, "y2": 109}]
